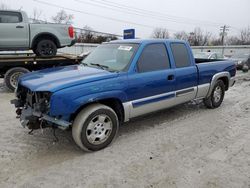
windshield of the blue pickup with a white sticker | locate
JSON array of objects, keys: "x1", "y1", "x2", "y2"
[{"x1": 82, "y1": 43, "x2": 139, "y2": 71}]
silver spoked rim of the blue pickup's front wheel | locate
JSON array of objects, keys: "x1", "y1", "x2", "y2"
[{"x1": 86, "y1": 114, "x2": 113, "y2": 145}]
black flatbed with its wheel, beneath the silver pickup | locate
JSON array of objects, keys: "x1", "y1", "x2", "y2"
[{"x1": 0, "y1": 53, "x2": 83, "y2": 91}]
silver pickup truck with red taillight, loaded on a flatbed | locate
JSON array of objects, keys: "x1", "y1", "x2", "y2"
[{"x1": 0, "y1": 10, "x2": 76, "y2": 56}]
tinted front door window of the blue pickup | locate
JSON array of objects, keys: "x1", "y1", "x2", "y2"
[{"x1": 137, "y1": 44, "x2": 170, "y2": 72}]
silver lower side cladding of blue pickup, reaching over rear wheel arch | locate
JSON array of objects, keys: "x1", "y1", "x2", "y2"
[{"x1": 123, "y1": 79, "x2": 231, "y2": 122}]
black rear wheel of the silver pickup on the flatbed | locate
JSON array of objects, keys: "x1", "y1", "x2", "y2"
[{"x1": 33, "y1": 39, "x2": 57, "y2": 57}]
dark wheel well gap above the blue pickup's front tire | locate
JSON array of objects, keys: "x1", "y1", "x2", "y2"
[{"x1": 70, "y1": 98, "x2": 124, "y2": 122}]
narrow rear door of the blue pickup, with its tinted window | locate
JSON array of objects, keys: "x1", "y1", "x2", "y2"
[{"x1": 170, "y1": 42, "x2": 198, "y2": 104}]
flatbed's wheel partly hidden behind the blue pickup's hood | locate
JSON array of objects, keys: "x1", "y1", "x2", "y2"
[{"x1": 4, "y1": 67, "x2": 30, "y2": 91}]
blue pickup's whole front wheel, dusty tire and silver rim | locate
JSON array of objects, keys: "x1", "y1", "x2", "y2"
[{"x1": 72, "y1": 104, "x2": 119, "y2": 151}]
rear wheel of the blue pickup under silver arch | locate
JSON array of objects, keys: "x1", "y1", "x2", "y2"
[{"x1": 203, "y1": 80, "x2": 225, "y2": 109}]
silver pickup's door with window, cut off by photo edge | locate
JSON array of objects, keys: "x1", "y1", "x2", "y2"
[{"x1": 0, "y1": 11, "x2": 29, "y2": 50}]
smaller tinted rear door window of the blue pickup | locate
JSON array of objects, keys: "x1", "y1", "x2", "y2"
[{"x1": 171, "y1": 43, "x2": 190, "y2": 68}]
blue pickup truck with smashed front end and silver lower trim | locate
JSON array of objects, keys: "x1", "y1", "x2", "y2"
[{"x1": 12, "y1": 40, "x2": 236, "y2": 151}]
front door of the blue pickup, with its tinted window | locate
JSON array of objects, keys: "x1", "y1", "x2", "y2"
[{"x1": 127, "y1": 43, "x2": 175, "y2": 118}]
